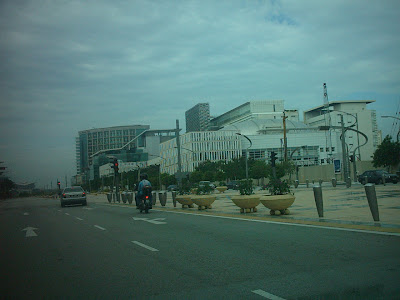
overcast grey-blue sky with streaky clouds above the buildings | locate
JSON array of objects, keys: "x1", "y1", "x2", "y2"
[{"x1": 0, "y1": 0, "x2": 400, "y2": 186}]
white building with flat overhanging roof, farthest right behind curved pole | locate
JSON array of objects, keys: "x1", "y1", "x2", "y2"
[{"x1": 304, "y1": 100, "x2": 381, "y2": 161}]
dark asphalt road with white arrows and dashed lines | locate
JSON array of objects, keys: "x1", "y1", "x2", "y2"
[{"x1": 0, "y1": 198, "x2": 400, "y2": 299}]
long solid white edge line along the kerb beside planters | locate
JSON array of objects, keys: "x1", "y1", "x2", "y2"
[{"x1": 153, "y1": 208, "x2": 400, "y2": 236}]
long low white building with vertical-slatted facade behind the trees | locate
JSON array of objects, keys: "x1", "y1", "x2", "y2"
[{"x1": 160, "y1": 119, "x2": 342, "y2": 174}]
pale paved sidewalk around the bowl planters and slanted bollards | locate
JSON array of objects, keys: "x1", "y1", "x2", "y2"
[{"x1": 88, "y1": 183, "x2": 400, "y2": 232}]
